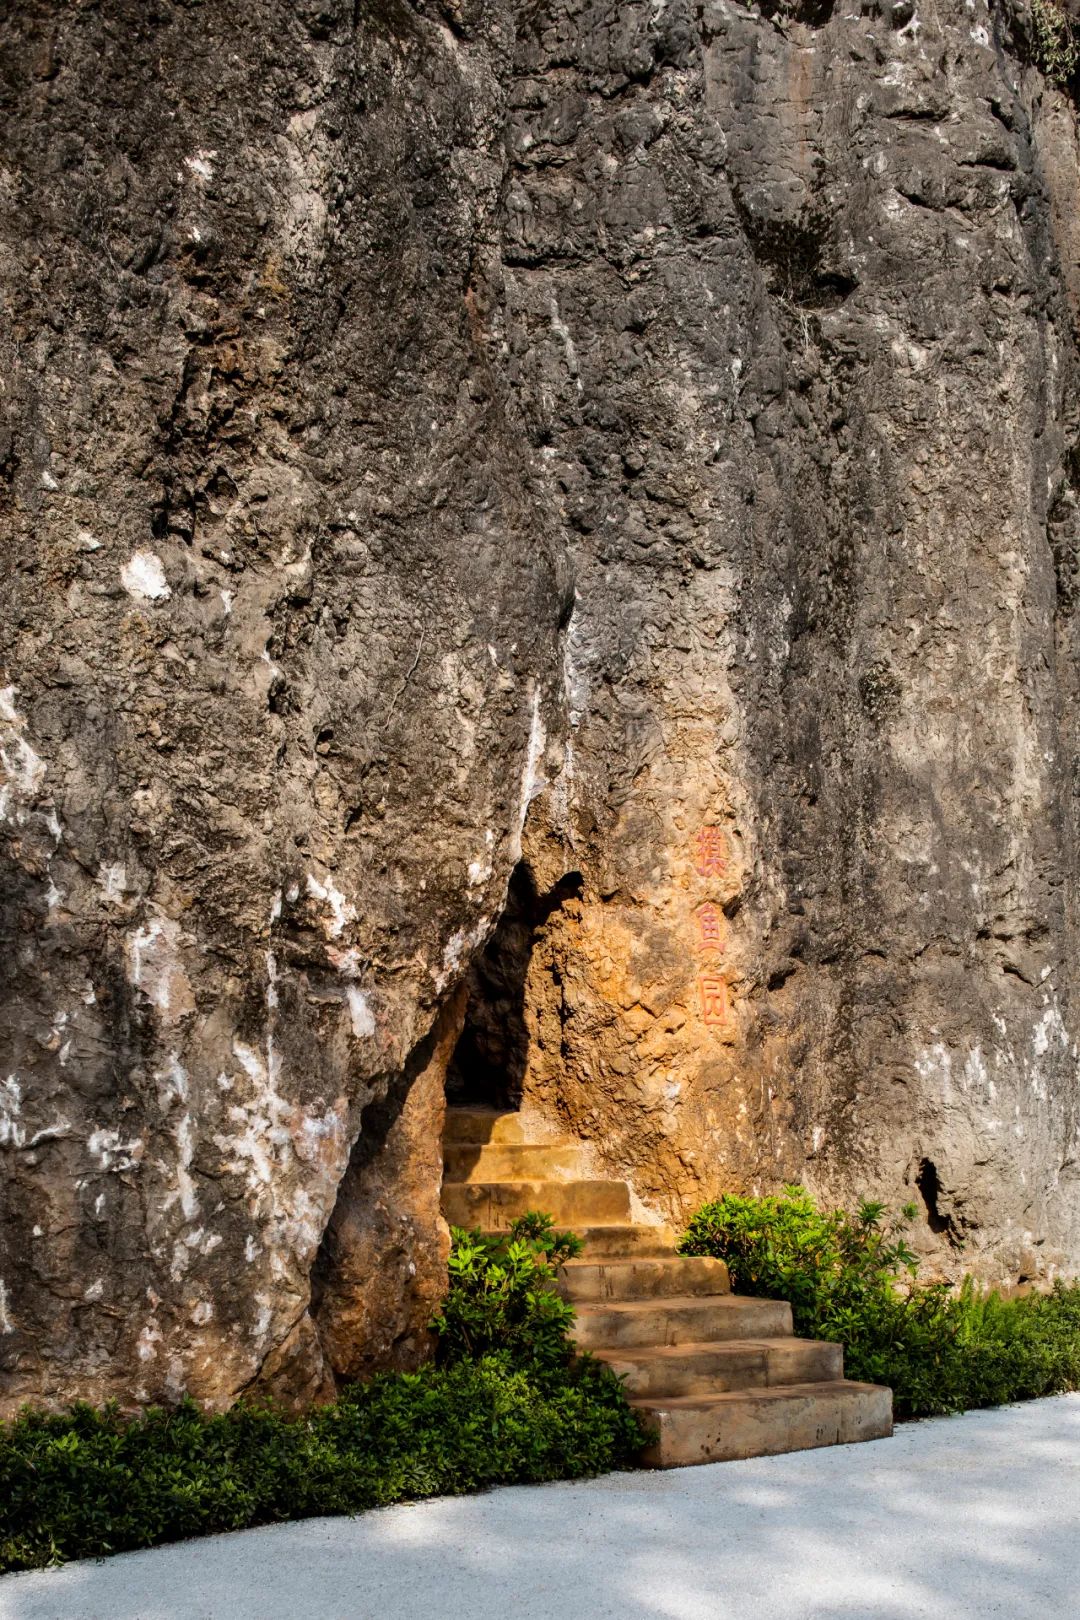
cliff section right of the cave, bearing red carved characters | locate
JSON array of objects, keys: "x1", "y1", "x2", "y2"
[{"x1": 505, "y1": 3, "x2": 1080, "y2": 1280}]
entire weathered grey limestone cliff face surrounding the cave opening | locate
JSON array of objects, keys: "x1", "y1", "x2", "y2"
[{"x1": 0, "y1": 0, "x2": 1080, "y2": 1406}]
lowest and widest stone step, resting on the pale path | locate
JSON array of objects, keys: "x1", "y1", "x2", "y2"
[{"x1": 631, "y1": 1382, "x2": 892, "y2": 1468}]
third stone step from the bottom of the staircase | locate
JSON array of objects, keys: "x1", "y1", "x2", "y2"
[{"x1": 573, "y1": 1294, "x2": 792, "y2": 1349}]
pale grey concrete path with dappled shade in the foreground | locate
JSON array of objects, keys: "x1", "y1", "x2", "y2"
[{"x1": 0, "y1": 1395, "x2": 1080, "y2": 1620}]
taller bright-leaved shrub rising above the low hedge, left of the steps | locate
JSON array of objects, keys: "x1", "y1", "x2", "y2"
[{"x1": 432, "y1": 1213, "x2": 581, "y2": 1369}]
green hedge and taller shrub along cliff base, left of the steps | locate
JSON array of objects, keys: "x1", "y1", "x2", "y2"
[{"x1": 0, "y1": 1217, "x2": 644, "y2": 1571}]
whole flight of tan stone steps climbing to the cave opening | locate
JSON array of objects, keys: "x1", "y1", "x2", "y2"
[{"x1": 442, "y1": 1108, "x2": 892, "y2": 1468}]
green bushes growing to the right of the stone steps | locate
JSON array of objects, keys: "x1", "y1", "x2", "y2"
[{"x1": 680, "y1": 1187, "x2": 1080, "y2": 1418}]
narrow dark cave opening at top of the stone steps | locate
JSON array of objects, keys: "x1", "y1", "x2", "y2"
[{"x1": 447, "y1": 862, "x2": 583, "y2": 1110}]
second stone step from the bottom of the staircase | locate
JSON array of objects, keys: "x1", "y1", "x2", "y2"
[{"x1": 594, "y1": 1338, "x2": 844, "y2": 1403}]
